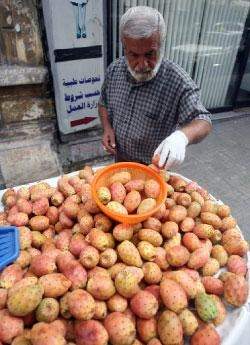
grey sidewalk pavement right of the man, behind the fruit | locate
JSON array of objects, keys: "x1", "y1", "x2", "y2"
[{"x1": 176, "y1": 116, "x2": 250, "y2": 240}]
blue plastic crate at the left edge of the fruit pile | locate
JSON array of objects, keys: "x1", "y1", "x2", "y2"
[{"x1": 0, "y1": 226, "x2": 19, "y2": 270}]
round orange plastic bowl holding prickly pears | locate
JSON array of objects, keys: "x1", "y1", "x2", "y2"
[{"x1": 92, "y1": 162, "x2": 167, "y2": 224}]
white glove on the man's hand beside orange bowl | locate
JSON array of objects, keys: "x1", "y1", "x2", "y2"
[{"x1": 154, "y1": 130, "x2": 188, "y2": 170}]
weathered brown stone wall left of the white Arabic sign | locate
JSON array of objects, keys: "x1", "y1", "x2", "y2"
[{"x1": 0, "y1": 0, "x2": 55, "y2": 128}]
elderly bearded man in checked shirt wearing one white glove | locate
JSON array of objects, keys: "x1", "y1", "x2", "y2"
[{"x1": 99, "y1": 6, "x2": 212, "y2": 169}]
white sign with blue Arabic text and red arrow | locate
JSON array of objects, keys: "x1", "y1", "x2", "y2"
[{"x1": 43, "y1": 0, "x2": 104, "y2": 134}]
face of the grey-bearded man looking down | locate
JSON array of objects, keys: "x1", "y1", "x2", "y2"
[{"x1": 122, "y1": 33, "x2": 162, "y2": 81}]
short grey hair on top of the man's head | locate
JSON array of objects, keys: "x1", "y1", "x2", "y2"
[{"x1": 120, "y1": 6, "x2": 166, "y2": 45}]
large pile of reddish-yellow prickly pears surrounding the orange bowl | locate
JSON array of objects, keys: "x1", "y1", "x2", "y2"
[{"x1": 0, "y1": 166, "x2": 248, "y2": 345}]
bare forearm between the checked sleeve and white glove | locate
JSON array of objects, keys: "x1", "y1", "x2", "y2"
[{"x1": 181, "y1": 120, "x2": 212, "y2": 145}]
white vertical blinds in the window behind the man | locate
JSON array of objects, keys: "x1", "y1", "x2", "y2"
[{"x1": 112, "y1": 0, "x2": 250, "y2": 108}]
